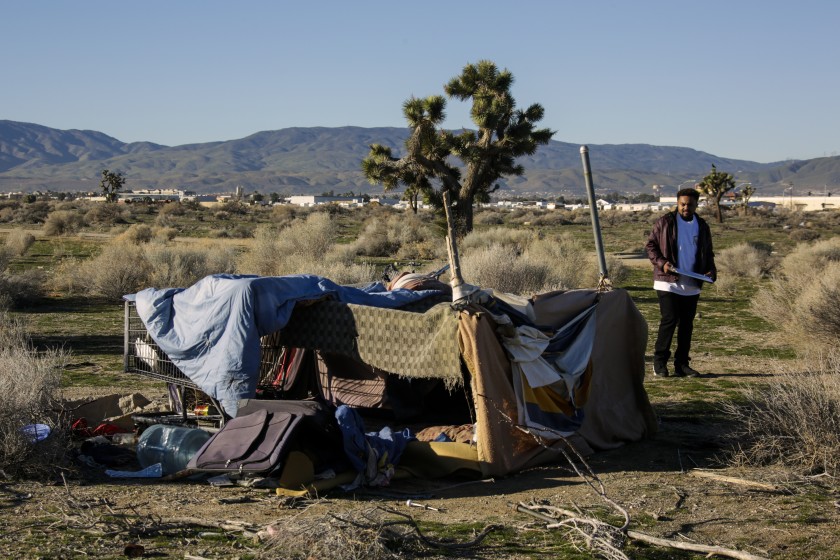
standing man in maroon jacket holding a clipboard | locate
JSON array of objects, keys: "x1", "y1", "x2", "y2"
[{"x1": 645, "y1": 188, "x2": 717, "y2": 377}]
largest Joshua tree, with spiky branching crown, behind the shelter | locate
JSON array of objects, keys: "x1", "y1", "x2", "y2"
[{"x1": 362, "y1": 60, "x2": 554, "y2": 235}]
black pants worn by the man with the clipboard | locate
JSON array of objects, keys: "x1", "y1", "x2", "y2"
[{"x1": 653, "y1": 290, "x2": 700, "y2": 366}]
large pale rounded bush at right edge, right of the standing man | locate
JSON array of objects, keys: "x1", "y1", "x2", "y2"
[{"x1": 751, "y1": 237, "x2": 840, "y2": 355}]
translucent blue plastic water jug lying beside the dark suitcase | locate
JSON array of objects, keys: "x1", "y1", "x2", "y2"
[{"x1": 137, "y1": 424, "x2": 210, "y2": 476}]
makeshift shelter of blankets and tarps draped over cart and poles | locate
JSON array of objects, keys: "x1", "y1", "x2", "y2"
[{"x1": 125, "y1": 275, "x2": 656, "y2": 476}]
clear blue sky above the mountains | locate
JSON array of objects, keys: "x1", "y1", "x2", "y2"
[{"x1": 0, "y1": 0, "x2": 840, "y2": 162}]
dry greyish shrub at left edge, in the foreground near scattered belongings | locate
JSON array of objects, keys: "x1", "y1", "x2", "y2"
[{"x1": 0, "y1": 312, "x2": 70, "y2": 478}]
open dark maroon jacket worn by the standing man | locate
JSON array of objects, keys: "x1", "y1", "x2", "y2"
[{"x1": 645, "y1": 212, "x2": 717, "y2": 282}]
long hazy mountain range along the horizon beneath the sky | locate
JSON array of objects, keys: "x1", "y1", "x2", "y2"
[{"x1": 0, "y1": 120, "x2": 840, "y2": 197}]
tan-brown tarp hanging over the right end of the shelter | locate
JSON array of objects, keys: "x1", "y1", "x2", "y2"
[{"x1": 458, "y1": 290, "x2": 656, "y2": 476}]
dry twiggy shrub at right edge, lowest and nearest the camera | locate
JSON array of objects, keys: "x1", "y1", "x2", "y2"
[{"x1": 726, "y1": 350, "x2": 840, "y2": 478}]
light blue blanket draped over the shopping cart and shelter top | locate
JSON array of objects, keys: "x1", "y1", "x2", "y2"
[{"x1": 126, "y1": 274, "x2": 439, "y2": 416}]
